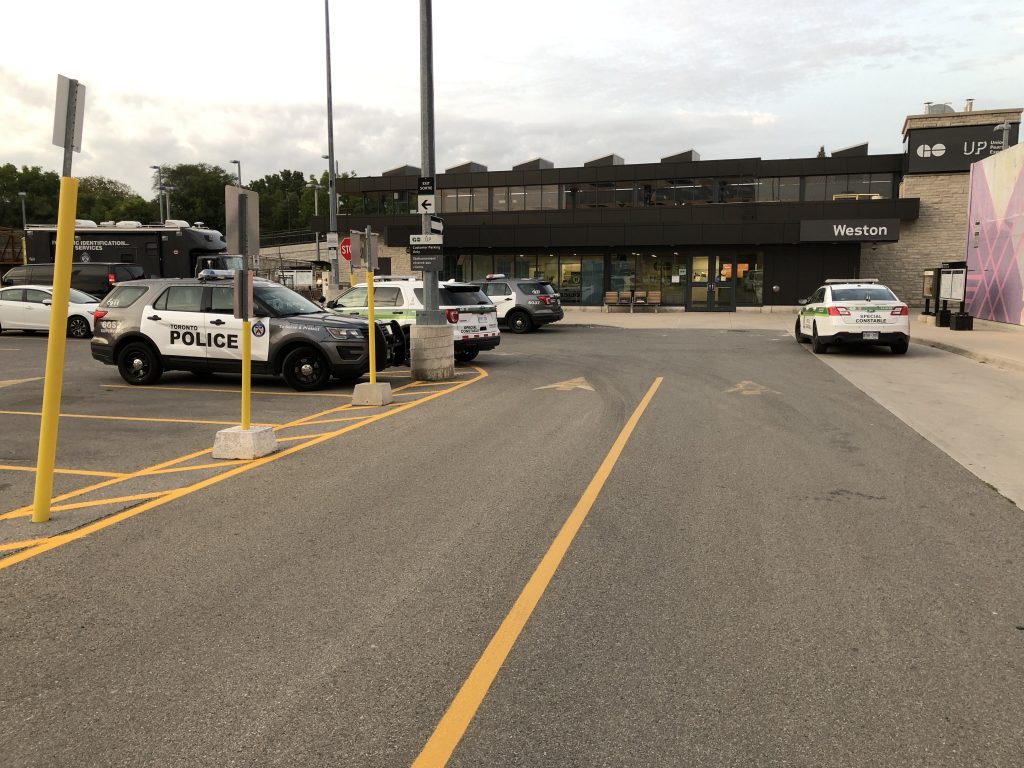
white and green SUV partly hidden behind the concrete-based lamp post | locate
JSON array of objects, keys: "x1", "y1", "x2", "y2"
[{"x1": 325, "y1": 278, "x2": 502, "y2": 362}]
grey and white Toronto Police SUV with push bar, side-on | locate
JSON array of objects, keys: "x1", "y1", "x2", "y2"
[{"x1": 91, "y1": 270, "x2": 406, "y2": 391}]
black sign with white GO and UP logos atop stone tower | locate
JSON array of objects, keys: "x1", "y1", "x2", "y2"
[{"x1": 906, "y1": 123, "x2": 1020, "y2": 173}]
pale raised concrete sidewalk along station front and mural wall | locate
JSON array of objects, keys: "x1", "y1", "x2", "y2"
[{"x1": 559, "y1": 307, "x2": 1024, "y2": 373}]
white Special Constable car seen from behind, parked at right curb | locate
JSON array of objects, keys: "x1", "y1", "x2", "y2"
[{"x1": 794, "y1": 280, "x2": 910, "y2": 354}]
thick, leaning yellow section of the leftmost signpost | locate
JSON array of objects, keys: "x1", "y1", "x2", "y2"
[{"x1": 32, "y1": 176, "x2": 78, "y2": 522}]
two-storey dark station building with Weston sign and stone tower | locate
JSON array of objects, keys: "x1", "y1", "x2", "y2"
[{"x1": 323, "y1": 102, "x2": 1022, "y2": 311}]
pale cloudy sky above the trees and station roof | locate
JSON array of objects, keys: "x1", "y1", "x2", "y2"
[{"x1": 0, "y1": 0, "x2": 1024, "y2": 199}]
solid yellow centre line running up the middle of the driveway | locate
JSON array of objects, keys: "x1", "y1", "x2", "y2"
[{"x1": 409, "y1": 376, "x2": 663, "y2": 768}]
